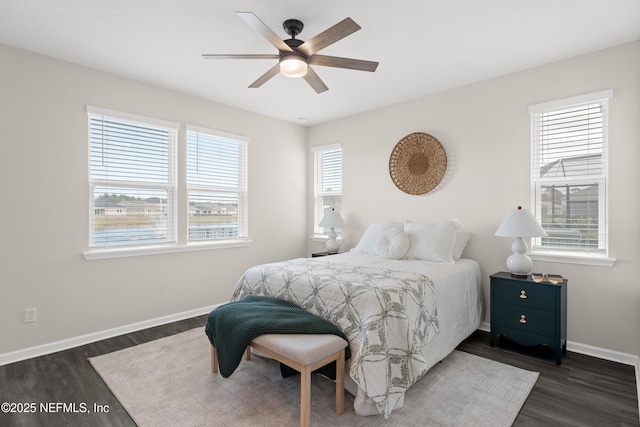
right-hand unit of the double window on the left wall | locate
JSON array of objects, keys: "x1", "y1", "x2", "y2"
[{"x1": 187, "y1": 126, "x2": 249, "y2": 242}]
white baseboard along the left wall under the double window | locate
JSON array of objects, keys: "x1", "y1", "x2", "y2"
[{"x1": 0, "y1": 304, "x2": 222, "y2": 366}]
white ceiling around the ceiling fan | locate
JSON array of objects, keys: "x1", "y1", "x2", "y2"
[{"x1": 0, "y1": 0, "x2": 640, "y2": 125}]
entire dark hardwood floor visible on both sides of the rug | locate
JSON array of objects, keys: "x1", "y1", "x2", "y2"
[{"x1": 0, "y1": 316, "x2": 640, "y2": 427}]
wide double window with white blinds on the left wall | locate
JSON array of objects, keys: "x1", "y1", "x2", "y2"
[{"x1": 83, "y1": 106, "x2": 250, "y2": 259}]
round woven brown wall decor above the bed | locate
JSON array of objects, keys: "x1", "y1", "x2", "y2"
[{"x1": 389, "y1": 132, "x2": 447, "y2": 194}]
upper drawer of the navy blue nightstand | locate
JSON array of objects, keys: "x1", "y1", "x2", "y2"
[{"x1": 493, "y1": 278, "x2": 557, "y2": 311}]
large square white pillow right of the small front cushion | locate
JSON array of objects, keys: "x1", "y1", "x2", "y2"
[{"x1": 404, "y1": 221, "x2": 456, "y2": 263}]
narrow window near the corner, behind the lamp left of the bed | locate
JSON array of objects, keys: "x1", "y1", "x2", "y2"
[{"x1": 312, "y1": 144, "x2": 342, "y2": 234}]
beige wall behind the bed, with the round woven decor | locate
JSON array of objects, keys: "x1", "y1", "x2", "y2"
[{"x1": 307, "y1": 41, "x2": 640, "y2": 355}]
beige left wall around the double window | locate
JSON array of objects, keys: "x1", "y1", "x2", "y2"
[{"x1": 0, "y1": 45, "x2": 307, "y2": 355}]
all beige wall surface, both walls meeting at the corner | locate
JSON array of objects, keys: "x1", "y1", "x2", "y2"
[{"x1": 0, "y1": 42, "x2": 640, "y2": 362}]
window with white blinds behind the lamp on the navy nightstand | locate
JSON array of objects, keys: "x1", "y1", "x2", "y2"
[{"x1": 529, "y1": 91, "x2": 612, "y2": 256}]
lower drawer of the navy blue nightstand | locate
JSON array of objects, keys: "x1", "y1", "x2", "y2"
[{"x1": 491, "y1": 302, "x2": 556, "y2": 337}]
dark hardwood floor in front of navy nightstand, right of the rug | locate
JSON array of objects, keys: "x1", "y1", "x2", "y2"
[{"x1": 458, "y1": 331, "x2": 640, "y2": 427}]
